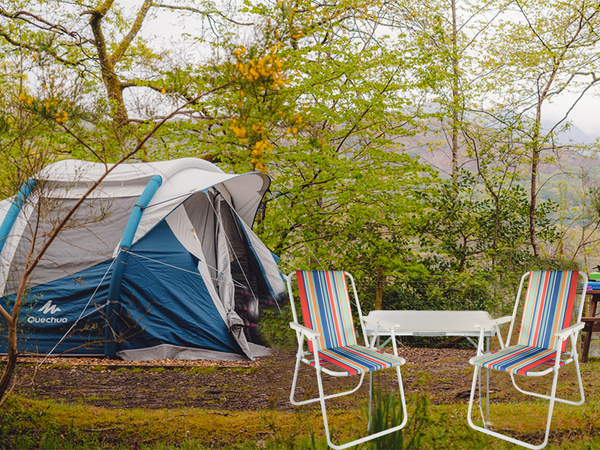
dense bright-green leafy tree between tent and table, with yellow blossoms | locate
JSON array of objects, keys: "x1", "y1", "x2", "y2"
[{"x1": 191, "y1": 0, "x2": 431, "y2": 306}]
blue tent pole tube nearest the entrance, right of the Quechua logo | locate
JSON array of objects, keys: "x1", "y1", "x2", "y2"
[{"x1": 104, "y1": 175, "x2": 162, "y2": 358}]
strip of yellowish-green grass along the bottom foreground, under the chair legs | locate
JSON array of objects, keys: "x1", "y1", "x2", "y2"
[{"x1": 0, "y1": 395, "x2": 600, "y2": 449}]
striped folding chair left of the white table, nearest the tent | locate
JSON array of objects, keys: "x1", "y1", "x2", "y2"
[{"x1": 287, "y1": 271, "x2": 408, "y2": 449}]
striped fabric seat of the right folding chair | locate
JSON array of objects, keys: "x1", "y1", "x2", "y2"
[{"x1": 469, "y1": 345, "x2": 565, "y2": 375}]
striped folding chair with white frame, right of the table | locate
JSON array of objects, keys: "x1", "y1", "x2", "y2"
[{"x1": 467, "y1": 271, "x2": 587, "y2": 449}]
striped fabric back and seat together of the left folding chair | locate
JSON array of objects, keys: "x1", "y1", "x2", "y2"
[{"x1": 296, "y1": 271, "x2": 401, "y2": 375}]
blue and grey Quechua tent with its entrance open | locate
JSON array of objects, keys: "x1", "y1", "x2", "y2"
[{"x1": 0, "y1": 158, "x2": 285, "y2": 360}]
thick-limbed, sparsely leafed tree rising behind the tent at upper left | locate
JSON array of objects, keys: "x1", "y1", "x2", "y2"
[{"x1": 0, "y1": 0, "x2": 239, "y2": 128}]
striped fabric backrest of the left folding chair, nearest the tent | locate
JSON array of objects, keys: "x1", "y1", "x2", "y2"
[{"x1": 296, "y1": 270, "x2": 356, "y2": 352}]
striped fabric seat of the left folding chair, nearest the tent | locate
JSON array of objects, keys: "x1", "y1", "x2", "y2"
[{"x1": 311, "y1": 345, "x2": 404, "y2": 375}]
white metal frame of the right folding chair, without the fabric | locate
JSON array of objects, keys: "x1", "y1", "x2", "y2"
[{"x1": 467, "y1": 272, "x2": 588, "y2": 449}]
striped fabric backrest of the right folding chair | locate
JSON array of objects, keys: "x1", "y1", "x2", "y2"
[{"x1": 519, "y1": 271, "x2": 579, "y2": 351}]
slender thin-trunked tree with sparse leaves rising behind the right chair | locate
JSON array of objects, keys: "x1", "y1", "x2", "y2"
[{"x1": 478, "y1": 0, "x2": 600, "y2": 257}]
